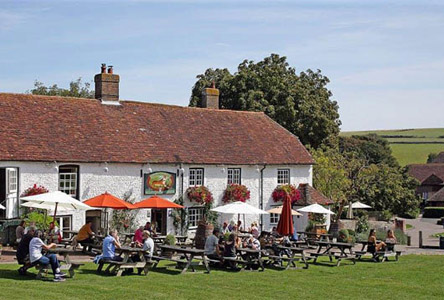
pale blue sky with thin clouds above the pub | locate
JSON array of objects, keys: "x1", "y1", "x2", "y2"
[{"x1": 0, "y1": 0, "x2": 444, "y2": 131}]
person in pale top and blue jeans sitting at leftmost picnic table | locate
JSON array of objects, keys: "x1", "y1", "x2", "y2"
[{"x1": 29, "y1": 231, "x2": 66, "y2": 281}]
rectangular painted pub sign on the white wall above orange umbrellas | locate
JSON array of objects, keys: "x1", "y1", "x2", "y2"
[{"x1": 143, "y1": 172, "x2": 176, "y2": 195}]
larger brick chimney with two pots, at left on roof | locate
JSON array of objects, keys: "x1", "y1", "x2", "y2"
[{"x1": 94, "y1": 64, "x2": 120, "y2": 103}]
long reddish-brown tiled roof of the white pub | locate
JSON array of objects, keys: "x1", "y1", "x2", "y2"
[{"x1": 0, "y1": 93, "x2": 313, "y2": 164}]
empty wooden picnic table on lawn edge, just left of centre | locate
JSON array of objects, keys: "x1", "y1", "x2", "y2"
[{"x1": 152, "y1": 245, "x2": 210, "y2": 274}]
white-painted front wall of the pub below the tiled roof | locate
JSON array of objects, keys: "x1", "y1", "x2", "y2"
[{"x1": 0, "y1": 162, "x2": 312, "y2": 232}]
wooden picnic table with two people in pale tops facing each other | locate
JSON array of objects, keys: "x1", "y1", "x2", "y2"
[{"x1": 97, "y1": 246, "x2": 152, "y2": 276}]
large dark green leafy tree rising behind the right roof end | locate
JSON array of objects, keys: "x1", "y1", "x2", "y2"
[{"x1": 189, "y1": 54, "x2": 341, "y2": 149}]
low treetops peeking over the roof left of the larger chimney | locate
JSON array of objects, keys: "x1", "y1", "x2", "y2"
[{"x1": 28, "y1": 78, "x2": 94, "y2": 98}]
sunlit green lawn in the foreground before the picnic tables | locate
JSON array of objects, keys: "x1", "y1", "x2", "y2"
[{"x1": 0, "y1": 255, "x2": 444, "y2": 299}]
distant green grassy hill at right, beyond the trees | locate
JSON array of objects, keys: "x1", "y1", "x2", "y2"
[{"x1": 340, "y1": 128, "x2": 444, "y2": 166}]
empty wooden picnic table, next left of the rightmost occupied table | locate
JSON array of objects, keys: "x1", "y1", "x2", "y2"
[{"x1": 310, "y1": 241, "x2": 356, "y2": 266}]
